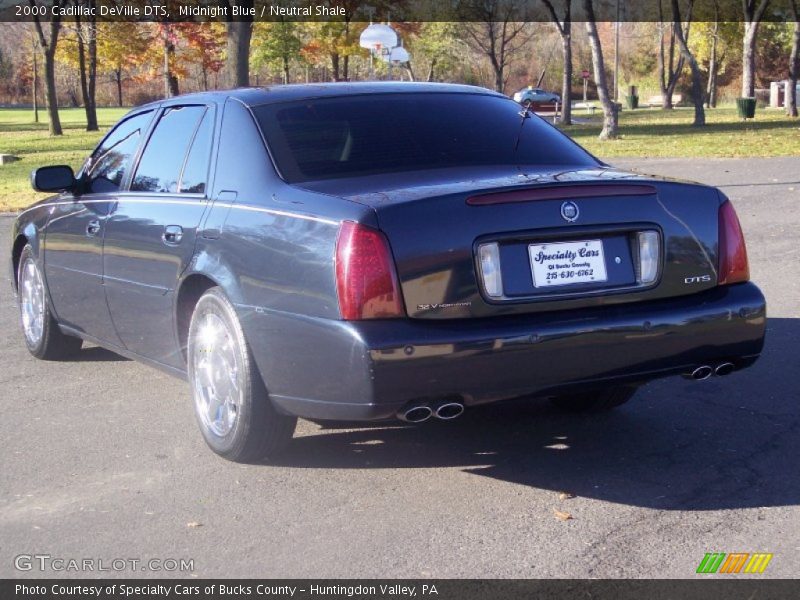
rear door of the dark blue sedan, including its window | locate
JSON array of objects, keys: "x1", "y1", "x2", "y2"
[{"x1": 103, "y1": 105, "x2": 215, "y2": 367}]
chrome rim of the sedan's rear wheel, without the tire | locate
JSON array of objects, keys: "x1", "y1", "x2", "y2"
[{"x1": 191, "y1": 313, "x2": 244, "y2": 437}]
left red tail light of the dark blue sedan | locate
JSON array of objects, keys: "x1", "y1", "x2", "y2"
[{"x1": 336, "y1": 221, "x2": 403, "y2": 321}]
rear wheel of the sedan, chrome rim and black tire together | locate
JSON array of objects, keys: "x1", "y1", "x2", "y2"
[{"x1": 187, "y1": 287, "x2": 297, "y2": 462}]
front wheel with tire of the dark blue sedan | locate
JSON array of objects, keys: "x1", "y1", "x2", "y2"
[{"x1": 17, "y1": 244, "x2": 83, "y2": 360}]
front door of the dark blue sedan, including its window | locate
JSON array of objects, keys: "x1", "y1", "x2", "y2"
[{"x1": 44, "y1": 110, "x2": 153, "y2": 345}]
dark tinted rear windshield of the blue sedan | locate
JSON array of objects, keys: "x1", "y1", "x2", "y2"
[{"x1": 253, "y1": 93, "x2": 597, "y2": 183}]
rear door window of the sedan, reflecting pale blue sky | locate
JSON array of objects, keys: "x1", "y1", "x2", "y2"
[{"x1": 131, "y1": 106, "x2": 206, "y2": 193}]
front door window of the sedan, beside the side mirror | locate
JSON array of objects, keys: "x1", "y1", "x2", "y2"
[{"x1": 84, "y1": 111, "x2": 153, "y2": 193}]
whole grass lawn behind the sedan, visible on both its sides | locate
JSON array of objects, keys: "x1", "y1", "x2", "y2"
[{"x1": 0, "y1": 108, "x2": 800, "y2": 212}]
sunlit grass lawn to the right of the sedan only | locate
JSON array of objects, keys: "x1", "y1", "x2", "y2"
[{"x1": 562, "y1": 107, "x2": 800, "y2": 158}]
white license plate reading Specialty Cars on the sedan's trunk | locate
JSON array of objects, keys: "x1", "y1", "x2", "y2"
[{"x1": 528, "y1": 240, "x2": 608, "y2": 288}]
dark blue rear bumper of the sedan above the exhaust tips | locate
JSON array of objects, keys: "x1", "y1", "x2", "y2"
[{"x1": 240, "y1": 283, "x2": 766, "y2": 420}]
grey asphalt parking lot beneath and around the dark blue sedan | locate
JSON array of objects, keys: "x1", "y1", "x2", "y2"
[{"x1": 0, "y1": 158, "x2": 800, "y2": 578}]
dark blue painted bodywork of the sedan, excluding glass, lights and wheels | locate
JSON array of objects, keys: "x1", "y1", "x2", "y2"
[{"x1": 7, "y1": 83, "x2": 766, "y2": 419}]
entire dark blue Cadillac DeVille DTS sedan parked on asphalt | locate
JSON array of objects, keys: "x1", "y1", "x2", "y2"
[{"x1": 11, "y1": 83, "x2": 766, "y2": 461}]
